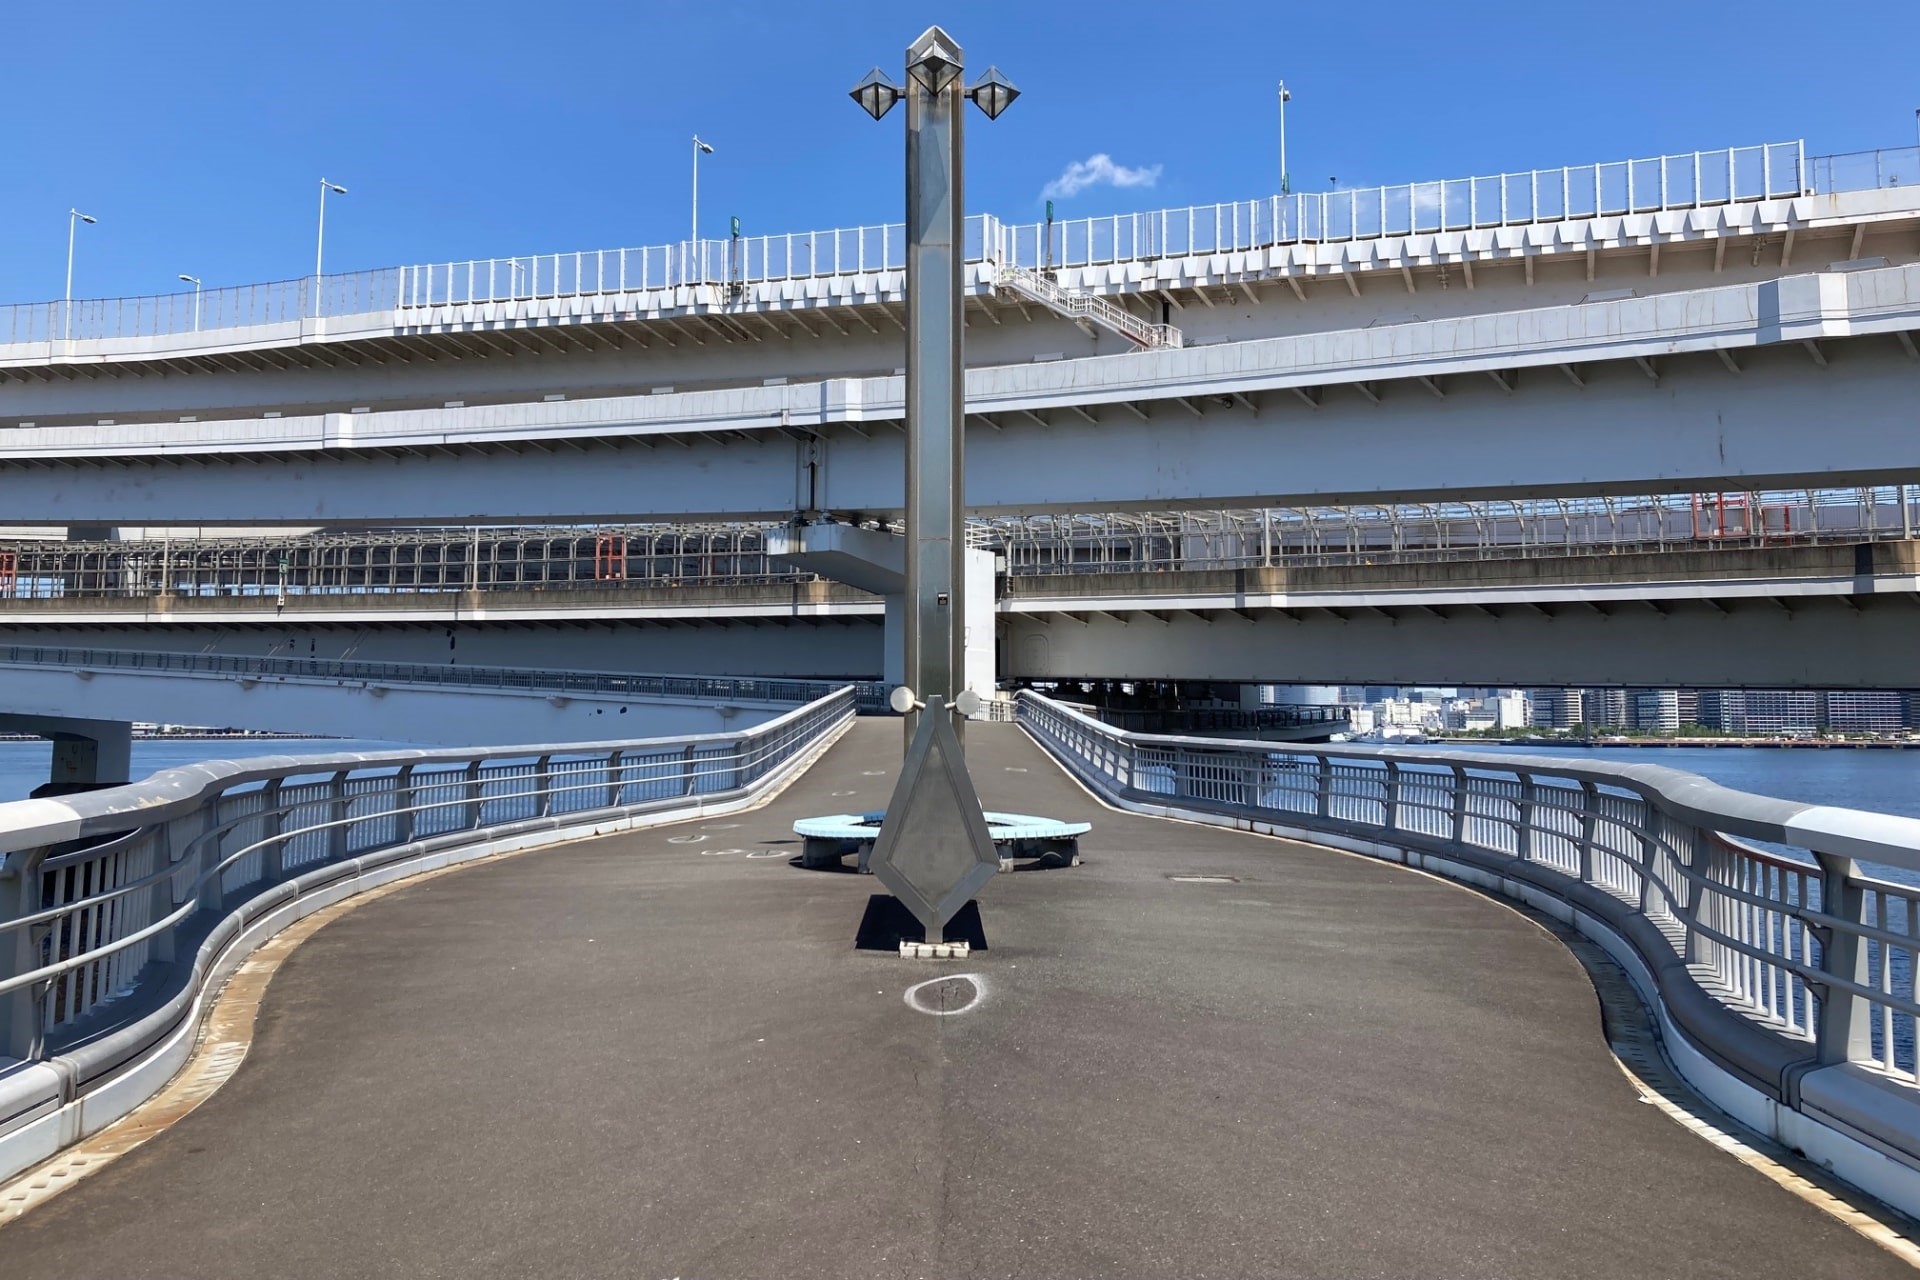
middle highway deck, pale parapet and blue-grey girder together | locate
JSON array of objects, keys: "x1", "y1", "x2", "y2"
[{"x1": 0, "y1": 265, "x2": 1920, "y2": 526}]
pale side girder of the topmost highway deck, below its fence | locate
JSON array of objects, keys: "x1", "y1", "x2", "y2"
[{"x1": 0, "y1": 188, "x2": 1920, "y2": 422}]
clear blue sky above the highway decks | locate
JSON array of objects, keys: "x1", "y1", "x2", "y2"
[{"x1": 0, "y1": 0, "x2": 1920, "y2": 301}]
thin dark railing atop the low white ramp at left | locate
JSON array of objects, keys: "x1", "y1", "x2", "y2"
[{"x1": 0, "y1": 645, "x2": 887, "y2": 712}]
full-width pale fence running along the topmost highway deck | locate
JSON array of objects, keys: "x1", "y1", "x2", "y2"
[{"x1": 18, "y1": 142, "x2": 1920, "y2": 347}]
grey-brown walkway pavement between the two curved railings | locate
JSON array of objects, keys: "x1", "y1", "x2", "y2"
[{"x1": 0, "y1": 722, "x2": 1908, "y2": 1280}]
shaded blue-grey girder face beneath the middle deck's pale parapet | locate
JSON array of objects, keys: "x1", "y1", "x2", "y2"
[{"x1": 0, "y1": 336, "x2": 1920, "y2": 526}]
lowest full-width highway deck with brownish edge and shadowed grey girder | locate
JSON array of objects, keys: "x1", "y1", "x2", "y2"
[{"x1": 0, "y1": 529, "x2": 1920, "y2": 689}]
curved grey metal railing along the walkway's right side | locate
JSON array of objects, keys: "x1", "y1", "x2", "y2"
[{"x1": 1016, "y1": 691, "x2": 1920, "y2": 1105}]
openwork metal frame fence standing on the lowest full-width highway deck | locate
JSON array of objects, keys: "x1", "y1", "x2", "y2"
[{"x1": 0, "y1": 486, "x2": 1920, "y2": 604}]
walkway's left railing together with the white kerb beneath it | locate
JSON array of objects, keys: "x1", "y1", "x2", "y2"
[{"x1": 0, "y1": 687, "x2": 854, "y2": 1180}]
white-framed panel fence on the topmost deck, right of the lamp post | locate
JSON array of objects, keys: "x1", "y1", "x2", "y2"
[{"x1": 1000, "y1": 142, "x2": 1804, "y2": 271}]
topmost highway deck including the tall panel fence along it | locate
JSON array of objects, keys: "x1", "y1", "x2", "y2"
[{"x1": 0, "y1": 144, "x2": 1920, "y2": 426}]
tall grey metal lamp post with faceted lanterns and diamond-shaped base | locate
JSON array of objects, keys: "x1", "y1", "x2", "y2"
[{"x1": 852, "y1": 27, "x2": 1020, "y2": 944}]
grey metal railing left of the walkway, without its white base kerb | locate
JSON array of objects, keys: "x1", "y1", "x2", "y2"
[{"x1": 0, "y1": 687, "x2": 856, "y2": 1061}]
